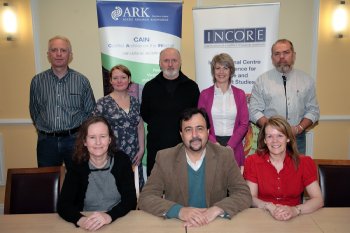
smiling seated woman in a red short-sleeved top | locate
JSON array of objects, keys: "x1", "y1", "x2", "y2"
[{"x1": 243, "y1": 116, "x2": 323, "y2": 220}]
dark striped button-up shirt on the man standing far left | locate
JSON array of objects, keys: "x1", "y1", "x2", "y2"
[{"x1": 29, "y1": 68, "x2": 95, "y2": 133}]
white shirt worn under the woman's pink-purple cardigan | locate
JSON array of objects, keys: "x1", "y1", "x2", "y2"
[{"x1": 211, "y1": 85, "x2": 237, "y2": 136}]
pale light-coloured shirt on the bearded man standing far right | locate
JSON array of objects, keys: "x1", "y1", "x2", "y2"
[{"x1": 249, "y1": 69, "x2": 320, "y2": 125}]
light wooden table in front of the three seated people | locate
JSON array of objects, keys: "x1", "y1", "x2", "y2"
[{"x1": 0, "y1": 208, "x2": 350, "y2": 233}]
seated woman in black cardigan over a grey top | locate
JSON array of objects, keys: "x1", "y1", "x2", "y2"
[{"x1": 57, "y1": 117, "x2": 136, "y2": 231}]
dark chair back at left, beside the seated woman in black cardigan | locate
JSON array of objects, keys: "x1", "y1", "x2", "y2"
[{"x1": 4, "y1": 166, "x2": 65, "y2": 214}]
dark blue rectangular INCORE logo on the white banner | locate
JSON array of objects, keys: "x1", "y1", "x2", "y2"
[{"x1": 204, "y1": 28, "x2": 266, "y2": 44}]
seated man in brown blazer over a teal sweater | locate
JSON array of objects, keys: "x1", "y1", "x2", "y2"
[{"x1": 139, "y1": 108, "x2": 252, "y2": 227}]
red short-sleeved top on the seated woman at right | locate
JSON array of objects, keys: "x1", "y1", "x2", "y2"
[{"x1": 243, "y1": 153, "x2": 317, "y2": 206}]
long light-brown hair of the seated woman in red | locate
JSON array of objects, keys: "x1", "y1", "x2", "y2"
[{"x1": 257, "y1": 116, "x2": 300, "y2": 168}]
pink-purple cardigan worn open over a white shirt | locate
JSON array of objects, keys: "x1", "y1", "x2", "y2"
[{"x1": 198, "y1": 85, "x2": 249, "y2": 166}]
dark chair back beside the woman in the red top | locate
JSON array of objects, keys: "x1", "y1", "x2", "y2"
[{"x1": 315, "y1": 160, "x2": 350, "y2": 207}]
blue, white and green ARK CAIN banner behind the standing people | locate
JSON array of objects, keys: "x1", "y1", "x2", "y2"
[{"x1": 96, "y1": 0, "x2": 182, "y2": 182}]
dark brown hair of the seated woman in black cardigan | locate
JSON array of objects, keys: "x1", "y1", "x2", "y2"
[{"x1": 73, "y1": 116, "x2": 117, "y2": 163}]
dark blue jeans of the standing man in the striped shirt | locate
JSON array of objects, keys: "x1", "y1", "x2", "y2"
[{"x1": 36, "y1": 133, "x2": 76, "y2": 170}]
